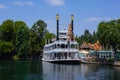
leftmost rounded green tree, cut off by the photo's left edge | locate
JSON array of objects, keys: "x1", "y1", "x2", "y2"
[{"x1": 0, "y1": 20, "x2": 15, "y2": 59}]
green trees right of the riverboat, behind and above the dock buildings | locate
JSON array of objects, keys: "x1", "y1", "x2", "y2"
[{"x1": 76, "y1": 19, "x2": 120, "y2": 58}]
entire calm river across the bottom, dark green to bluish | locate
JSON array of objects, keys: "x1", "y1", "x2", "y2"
[{"x1": 0, "y1": 61, "x2": 120, "y2": 80}]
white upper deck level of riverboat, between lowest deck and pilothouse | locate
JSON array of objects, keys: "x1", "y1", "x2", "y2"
[{"x1": 43, "y1": 40, "x2": 79, "y2": 53}]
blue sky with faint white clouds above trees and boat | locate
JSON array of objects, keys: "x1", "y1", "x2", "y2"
[{"x1": 0, "y1": 0, "x2": 120, "y2": 36}]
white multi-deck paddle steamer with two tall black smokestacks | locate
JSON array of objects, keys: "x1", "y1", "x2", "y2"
[{"x1": 42, "y1": 14, "x2": 80, "y2": 64}]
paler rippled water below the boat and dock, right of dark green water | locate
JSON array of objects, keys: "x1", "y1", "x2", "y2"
[{"x1": 43, "y1": 63, "x2": 120, "y2": 80}]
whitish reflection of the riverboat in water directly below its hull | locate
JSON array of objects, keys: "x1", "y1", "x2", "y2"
[{"x1": 43, "y1": 63, "x2": 80, "y2": 80}]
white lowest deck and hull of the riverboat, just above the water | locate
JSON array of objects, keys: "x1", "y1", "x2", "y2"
[{"x1": 43, "y1": 52, "x2": 80, "y2": 64}]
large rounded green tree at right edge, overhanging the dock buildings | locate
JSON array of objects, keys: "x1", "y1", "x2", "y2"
[{"x1": 98, "y1": 19, "x2": 120, "y2": 58}]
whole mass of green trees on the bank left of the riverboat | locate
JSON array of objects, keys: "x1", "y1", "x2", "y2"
[{"x1": 0, "y1": 20, "x2": 55, "y2": 60}]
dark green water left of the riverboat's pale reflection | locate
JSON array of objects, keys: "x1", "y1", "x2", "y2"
[{"x1": 0, "y1": 61, "x2": 43, "y2": 80}]
